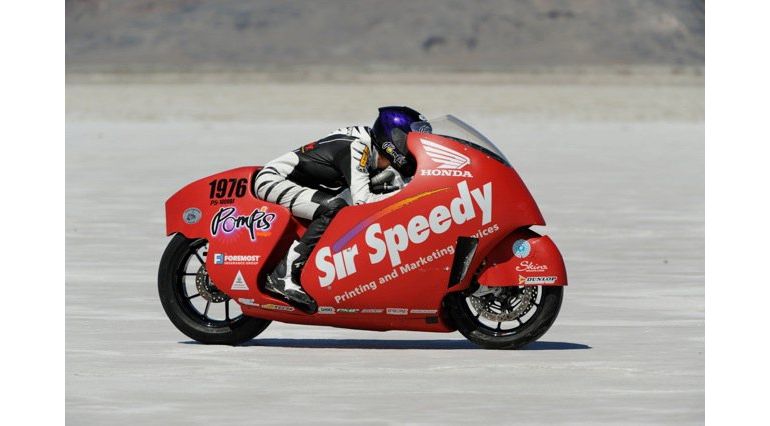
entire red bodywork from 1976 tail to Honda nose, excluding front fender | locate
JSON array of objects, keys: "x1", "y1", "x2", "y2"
[{"x1": 166, "y1": 132, "x2": 545, "y2": 331}]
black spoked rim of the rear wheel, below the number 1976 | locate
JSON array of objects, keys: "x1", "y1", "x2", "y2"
[{"x1": 174, "y1": 239, "x2": 246, "y2": 328}]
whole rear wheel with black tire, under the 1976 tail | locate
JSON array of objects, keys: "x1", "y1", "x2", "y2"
[{"x1": 158, "y1": 234, "x2": 270, "y2": 345}]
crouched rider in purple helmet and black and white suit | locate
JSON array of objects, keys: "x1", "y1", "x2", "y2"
[{"x1": 254, "y1": 106, "x2": 430, "y2": 313}]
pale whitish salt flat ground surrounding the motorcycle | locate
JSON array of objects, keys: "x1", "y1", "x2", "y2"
[{"x1": 66, "y1": 81, "x2": 704, "y2": 424}]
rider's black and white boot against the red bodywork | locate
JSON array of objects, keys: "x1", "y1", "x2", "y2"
[{"x1": 265, "y1": 241, "x2": 318, "y2": 314}]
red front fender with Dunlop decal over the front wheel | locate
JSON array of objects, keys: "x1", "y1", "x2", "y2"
[{"x1": 478, "y1": 228, "x2": 567, "y2": 287}]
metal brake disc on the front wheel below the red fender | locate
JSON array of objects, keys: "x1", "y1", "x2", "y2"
[{"x1": 469, "y1": 286, "x2": 537, "y2": 322}]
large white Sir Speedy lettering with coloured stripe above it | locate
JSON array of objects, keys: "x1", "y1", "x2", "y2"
[{"x1": 315, "y1": 181, "x2": 492, "y2": 287}]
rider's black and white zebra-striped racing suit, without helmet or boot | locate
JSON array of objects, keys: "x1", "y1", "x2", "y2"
[{"x1": 254, "y1": 126, "x2": 397, "y2": 268}]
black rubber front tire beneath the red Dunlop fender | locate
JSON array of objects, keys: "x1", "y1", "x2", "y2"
[{"x1": 444, "y1": 286, "x2": 564, "y2": 349}]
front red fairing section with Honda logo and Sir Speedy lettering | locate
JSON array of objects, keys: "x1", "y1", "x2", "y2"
[{"x1": 302, "y1": 133, "x2": 544, "y2": 326}]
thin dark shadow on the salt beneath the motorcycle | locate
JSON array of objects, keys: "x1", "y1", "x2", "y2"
[{"x1": 182, "y1": 338, "x2": 591, "y2": 351}]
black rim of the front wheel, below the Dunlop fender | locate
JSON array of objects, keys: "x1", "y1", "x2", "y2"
[{"x1": 462, "y1": 286, "x2": 544, "y2": 337}]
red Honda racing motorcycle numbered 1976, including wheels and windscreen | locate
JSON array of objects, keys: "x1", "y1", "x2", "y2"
[{"x1": 158, "y1": 115, "x2": 567, "y2": 349}]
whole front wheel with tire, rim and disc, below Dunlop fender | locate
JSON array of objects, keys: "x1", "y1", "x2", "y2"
[{"x1": 445, "y1": 286, "x2": 564, "y2": 349}]
